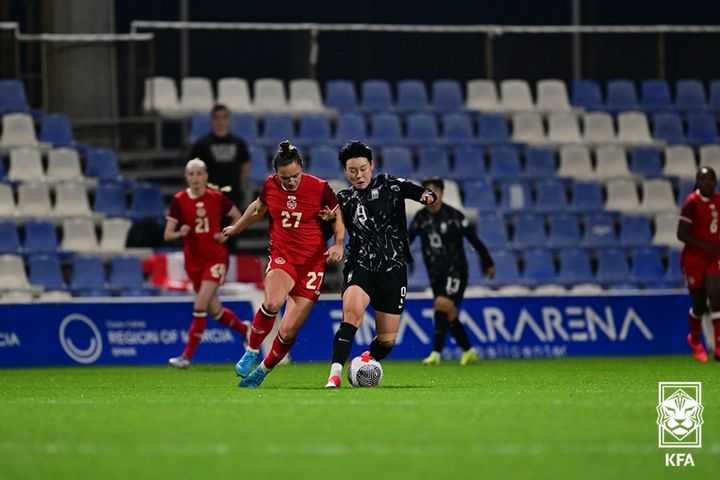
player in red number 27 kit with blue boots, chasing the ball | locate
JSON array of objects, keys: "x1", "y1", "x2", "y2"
[{"x1": 223, "y1": 141, "x2": 345, "y2": 388}]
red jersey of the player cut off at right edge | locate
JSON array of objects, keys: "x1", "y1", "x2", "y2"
[{"x1": 680, "y1": 190, "x2": 720, "y2": 260}]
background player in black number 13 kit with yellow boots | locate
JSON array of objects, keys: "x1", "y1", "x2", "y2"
[{"x1": 410, "y1": 178, "x2": 495, "y2": 365}]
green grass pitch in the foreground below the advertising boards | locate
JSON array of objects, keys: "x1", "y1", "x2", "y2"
[{"x1": 0, "y1": 355, "x2": 720, "y2": 480}]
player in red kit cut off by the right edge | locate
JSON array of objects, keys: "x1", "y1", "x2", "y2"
[{"x1": 677, "y1": 167, "x2": 720, "y2": 362}]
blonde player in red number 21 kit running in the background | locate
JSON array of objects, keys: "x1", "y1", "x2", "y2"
[{"x1": 164, "y1": 158, "x2": 249, "y2": 368}]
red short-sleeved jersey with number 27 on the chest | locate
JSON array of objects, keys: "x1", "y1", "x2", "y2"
[{"x1": 259, "y1": 173, "x2": 338, "y2": 264}]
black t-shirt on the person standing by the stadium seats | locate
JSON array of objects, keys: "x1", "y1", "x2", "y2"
[{"x1": 190, "y1": 133, "x2": 250, "y2": 204}]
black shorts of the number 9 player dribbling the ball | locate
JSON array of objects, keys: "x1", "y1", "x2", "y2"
[{"x1": 342, "y1": 266, "x2": 407, "y2": 315}]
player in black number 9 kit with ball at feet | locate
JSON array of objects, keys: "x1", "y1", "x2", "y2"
[{"x1": 325, "y1": 142, "x2": 437, "y2": 388}]
